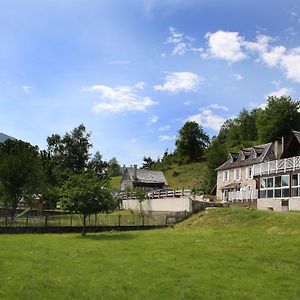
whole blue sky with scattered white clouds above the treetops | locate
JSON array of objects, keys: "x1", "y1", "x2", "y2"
[{"x1": 0, "y1": 0, "x2": 300, "y2": 165}]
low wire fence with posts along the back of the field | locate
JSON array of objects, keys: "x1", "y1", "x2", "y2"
[{"x1": 0, "y1": 212, "x2": 187, "y2": 227}]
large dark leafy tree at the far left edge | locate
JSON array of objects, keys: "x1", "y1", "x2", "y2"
[{"x1": 0, "y1": 140, "x2": 44, "y2": 219}]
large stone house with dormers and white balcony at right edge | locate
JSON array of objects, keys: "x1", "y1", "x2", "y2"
[{"x1": 217, "y1": 131, "x2": 300, "y2": 211}]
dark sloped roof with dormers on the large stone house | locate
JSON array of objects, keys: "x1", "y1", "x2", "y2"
[{"x1": 216, "y1": 143, "x2": 275, "y2": 171}]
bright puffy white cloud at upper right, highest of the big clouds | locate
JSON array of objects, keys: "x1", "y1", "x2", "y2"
[{"x1": 205, "y1": 30, "x2": 247, "y2": 62}]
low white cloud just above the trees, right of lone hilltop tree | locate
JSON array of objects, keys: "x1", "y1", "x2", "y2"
[{"x1": 188, "y1": 109, "x2": 226, "y2": 131}]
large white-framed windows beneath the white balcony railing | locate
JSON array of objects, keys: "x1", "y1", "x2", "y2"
[{"x1": 259, "y1": 175, "x2": 290, "y2": 198}]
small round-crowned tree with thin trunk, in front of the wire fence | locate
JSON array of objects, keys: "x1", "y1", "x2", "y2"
[{"x1": 61, "y1": 173, "x2": 117, "y2": 235}]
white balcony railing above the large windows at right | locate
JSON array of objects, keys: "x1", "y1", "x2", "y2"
[{"x1": 253, "y1": 156, "x2": 300, "y2": 176}]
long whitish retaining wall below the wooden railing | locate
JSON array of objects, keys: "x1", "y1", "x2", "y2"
[{"x1": 122, "y1": 197, "x2": 192, "y2": 212}]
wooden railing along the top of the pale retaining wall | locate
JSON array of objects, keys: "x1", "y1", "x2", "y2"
[{"x1": 118, "y1": 189, "x2": 191, "y2": 200}]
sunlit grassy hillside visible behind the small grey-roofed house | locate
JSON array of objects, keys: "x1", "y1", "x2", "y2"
[{"x1": 111, "y1": 162, "x2": 207, "y2": 190}]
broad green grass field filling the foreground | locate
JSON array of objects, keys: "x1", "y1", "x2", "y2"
[{"x1": 0, "y1": 208, "x2": 300, "y2": 300}]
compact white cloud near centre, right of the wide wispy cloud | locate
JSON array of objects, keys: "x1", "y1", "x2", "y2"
[{"x1": 154, "y1": 72, "x2": 204, "y2": 94}]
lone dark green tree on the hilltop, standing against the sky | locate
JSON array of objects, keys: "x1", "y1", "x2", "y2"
[{"x1": 175, "y1": 121, "x2": 209, "y2": 163}]
